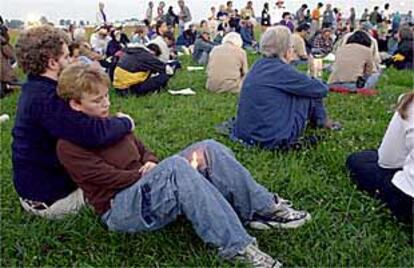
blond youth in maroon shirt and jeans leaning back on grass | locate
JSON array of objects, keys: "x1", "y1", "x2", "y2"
[{"x1": 57, "y1": 64, "x2": 310, "y2": 267}]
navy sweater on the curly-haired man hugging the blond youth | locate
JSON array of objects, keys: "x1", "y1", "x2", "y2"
[{"x1": 12, "y1": 76, "x2": 131, "y2": 204}]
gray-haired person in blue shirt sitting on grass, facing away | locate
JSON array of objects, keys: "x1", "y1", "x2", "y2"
[{"x1": 230, "y1": 26, "x2": 340, "y2": 149}]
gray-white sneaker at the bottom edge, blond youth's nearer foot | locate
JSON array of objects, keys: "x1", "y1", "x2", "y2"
[{"x1": 233, "y1": 243, "x2": 282, "y2": 268}]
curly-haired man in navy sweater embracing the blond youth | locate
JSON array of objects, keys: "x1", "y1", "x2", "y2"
[{"x1": 12, "y1": 26, "x2": 135, "y2": 218}]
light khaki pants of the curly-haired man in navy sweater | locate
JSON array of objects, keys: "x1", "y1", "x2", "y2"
[{"x1": 20, "y1": 188, "x2": 85, "y2": 220}]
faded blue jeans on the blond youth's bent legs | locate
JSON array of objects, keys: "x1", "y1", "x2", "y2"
[{"x1": 102, "y1": 140, "x2": 274, "y2": 258}]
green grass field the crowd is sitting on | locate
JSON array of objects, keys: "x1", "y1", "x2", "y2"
[{"x1": 0, "y1": 36, "x2": 414, "y2": 267}]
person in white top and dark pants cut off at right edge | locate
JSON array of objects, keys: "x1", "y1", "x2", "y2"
[{"x1": 346, "y1": 92, "x2": 414, "y2": 225}]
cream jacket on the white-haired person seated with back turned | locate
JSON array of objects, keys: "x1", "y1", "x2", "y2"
[{"x1": 206, "y1": 39, "x2": 248, "y2": 93}]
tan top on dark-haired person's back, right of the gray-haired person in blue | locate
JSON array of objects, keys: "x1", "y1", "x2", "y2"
[{"x1": 328, "y1": 44, "x2": 374, "y2": 84}]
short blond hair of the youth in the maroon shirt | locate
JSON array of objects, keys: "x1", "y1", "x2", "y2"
[{"x1": 57, "y1": 63, "x2": 111, "y2": 101}]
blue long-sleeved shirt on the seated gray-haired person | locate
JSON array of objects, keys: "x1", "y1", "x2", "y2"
[{"x1": 233, "y1": 58, "x2": 328, "y2": 149}]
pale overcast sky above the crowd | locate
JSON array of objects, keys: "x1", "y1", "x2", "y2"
[{"x1": 0, "y1": 0, "x2": 414, "y2": 23}]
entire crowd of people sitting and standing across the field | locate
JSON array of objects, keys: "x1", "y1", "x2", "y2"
[{"x1": 1, "y1": 0, "x2": 414, "y2": 267}]
